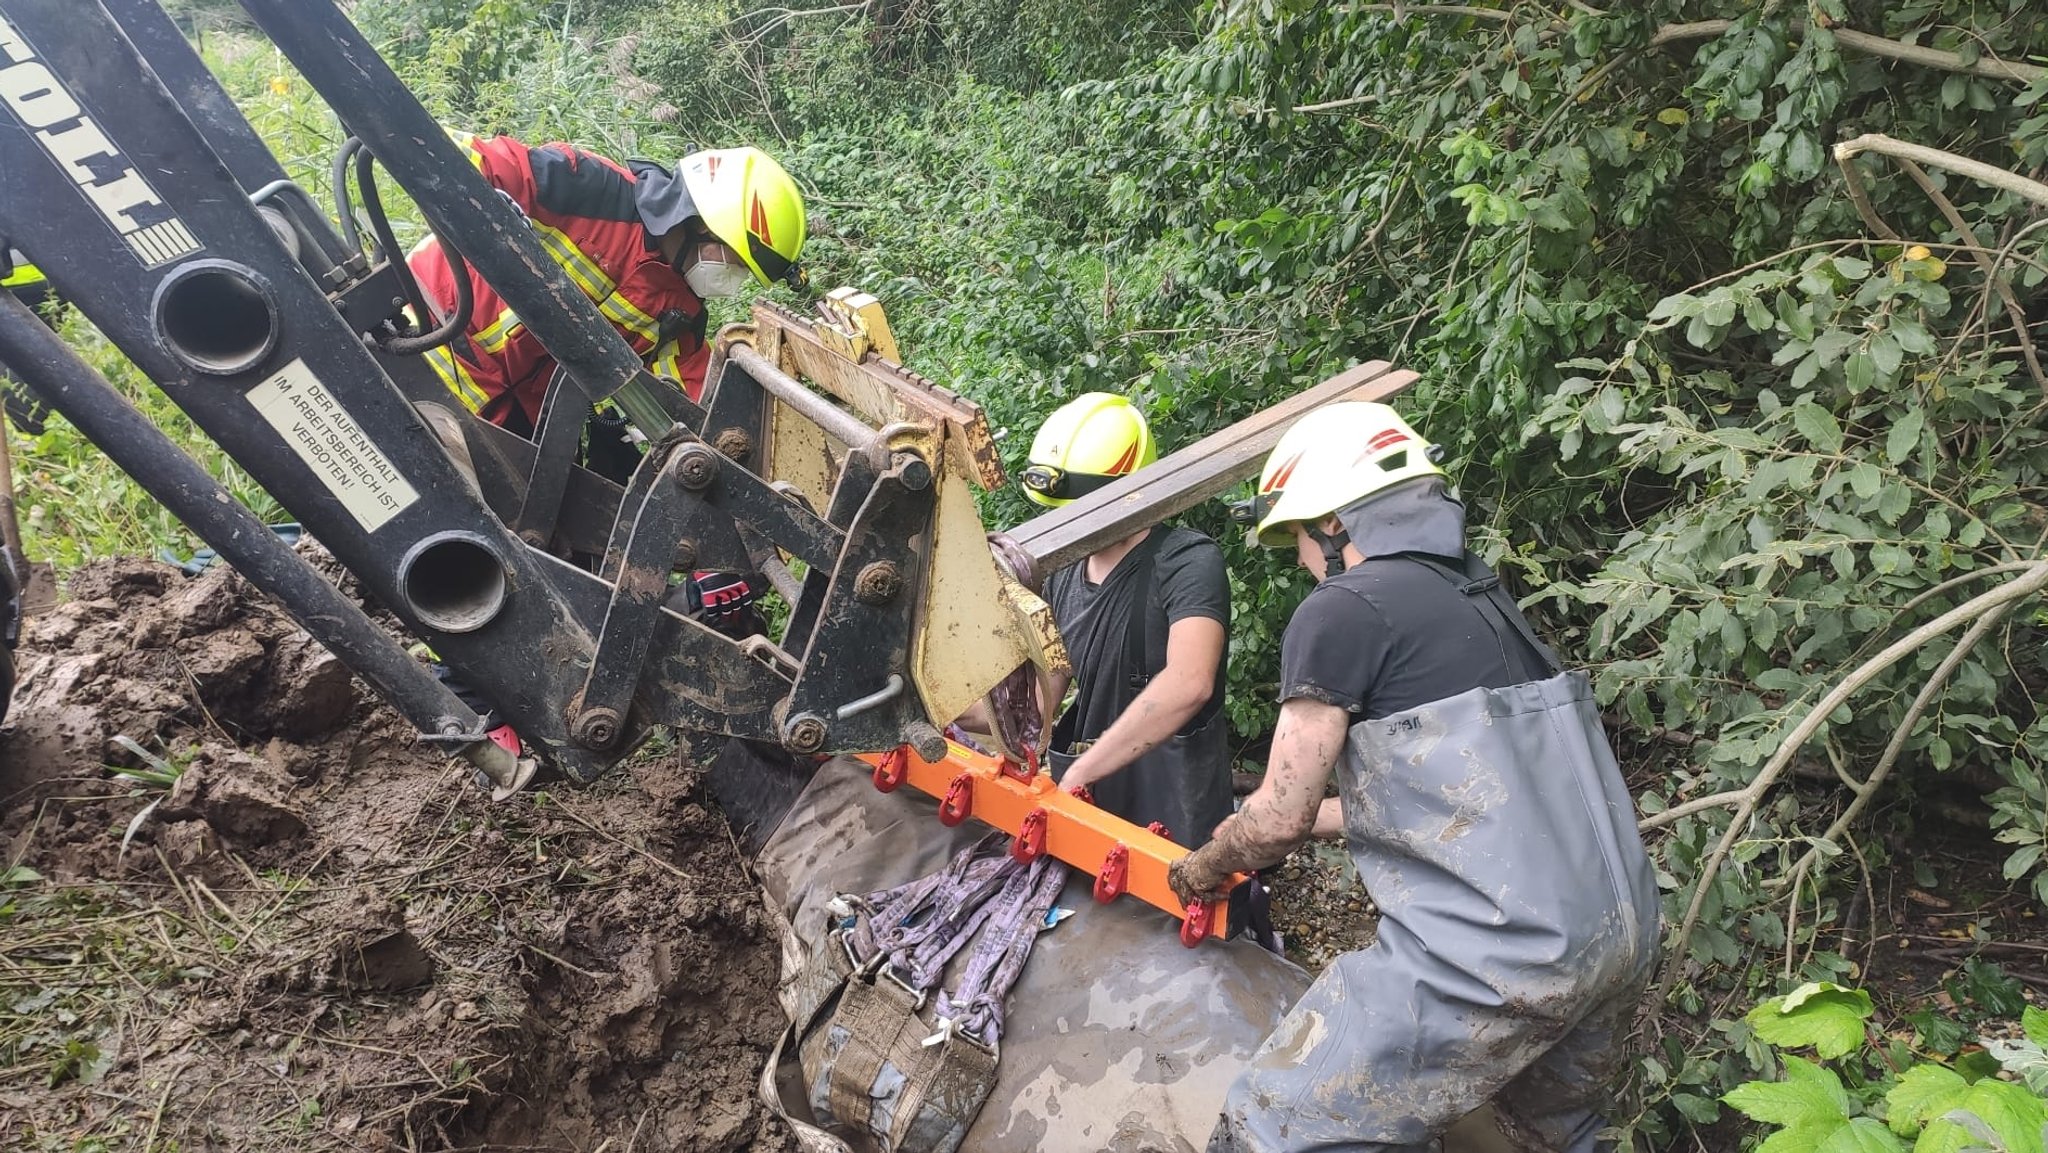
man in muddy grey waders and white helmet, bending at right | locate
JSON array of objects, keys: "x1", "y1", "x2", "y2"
[{"x1": 1167, "y1": 403, "x2": 1659, "y2": 1153}]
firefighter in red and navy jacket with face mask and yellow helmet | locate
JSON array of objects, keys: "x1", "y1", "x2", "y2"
[{"x1": 408, "y1": 133, "x2": 805, "y2": 436}]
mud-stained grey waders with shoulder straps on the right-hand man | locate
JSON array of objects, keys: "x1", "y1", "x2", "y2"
[{"x1": 1208, "y1": 559, "x2": 1659, "y2": 1153}]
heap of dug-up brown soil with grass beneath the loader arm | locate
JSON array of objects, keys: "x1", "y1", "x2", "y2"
[{"x1": 0, "y1": 561, "x2": 793, "y2": 1153}]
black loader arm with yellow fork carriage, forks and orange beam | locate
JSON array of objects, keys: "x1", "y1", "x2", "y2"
[{"x1": 0, "y1": 0, "x2": 1413, "y2": 940}]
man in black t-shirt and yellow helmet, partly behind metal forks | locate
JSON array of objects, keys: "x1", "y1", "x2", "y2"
[{"x1": 1022, "y1": 393, "x2": 1231, "y2": 846}]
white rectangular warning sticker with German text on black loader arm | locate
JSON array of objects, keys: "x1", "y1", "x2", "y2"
[{"x1": 248, "y1": 360, "x2": 420, "y2": 532}]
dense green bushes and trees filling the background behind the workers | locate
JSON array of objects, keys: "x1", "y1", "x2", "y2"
[{"x1": 12, "y1": 0, "x2": 2048, "y2": 1147}]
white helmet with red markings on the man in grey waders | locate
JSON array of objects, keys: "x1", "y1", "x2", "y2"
[{"x1": 1251, "y1": 401, "x2": 1444, "y2": 549}]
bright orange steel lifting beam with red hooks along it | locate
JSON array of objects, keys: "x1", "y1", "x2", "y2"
[{"x1": 860, "y1": 741, "x2": 1247, "y2": 948}]
